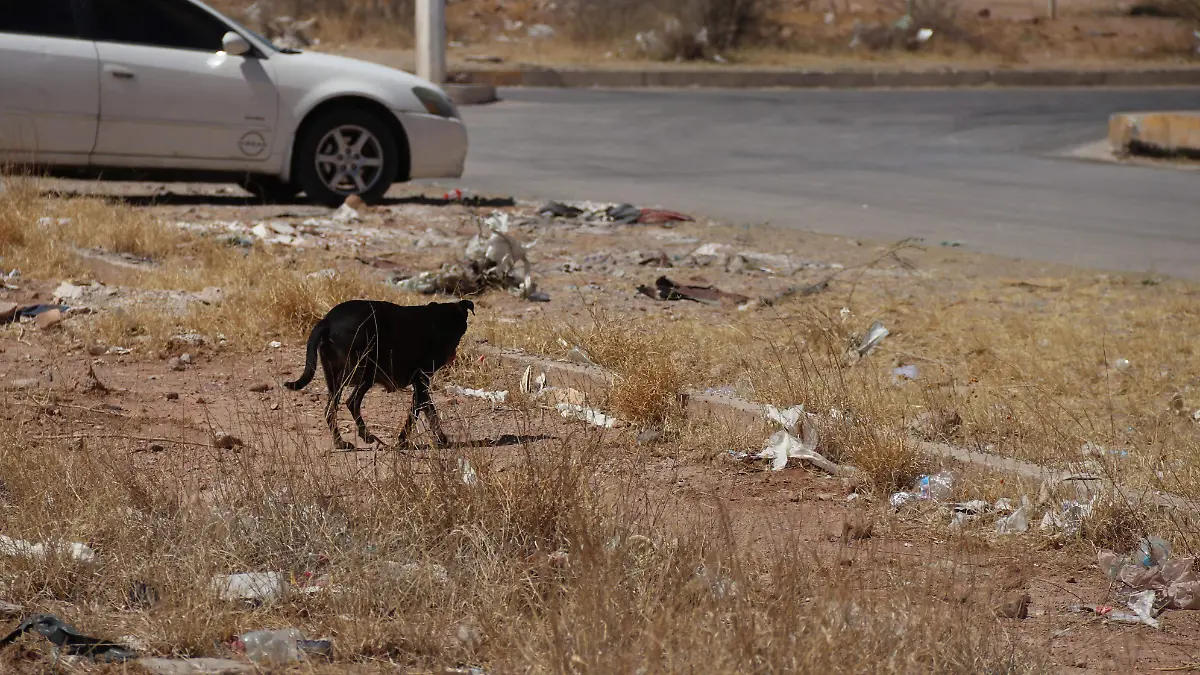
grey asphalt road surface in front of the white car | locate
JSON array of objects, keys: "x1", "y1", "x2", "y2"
[{"x1": 460, "y1": 89, "x2": 1200, "y2": 279}]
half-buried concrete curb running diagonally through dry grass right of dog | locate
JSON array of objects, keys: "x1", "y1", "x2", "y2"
[{"x1": 480, "y1": 346, "x2": 1200, "y2": 513}]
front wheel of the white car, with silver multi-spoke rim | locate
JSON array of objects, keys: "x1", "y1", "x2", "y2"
[{"x1": 292, "y1": 108, "x2": 400, "y2": 208}]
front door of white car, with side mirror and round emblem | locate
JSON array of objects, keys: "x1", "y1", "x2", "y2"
[{"x1": 85, "y1": 0, "x2": 278, "y2": 169}]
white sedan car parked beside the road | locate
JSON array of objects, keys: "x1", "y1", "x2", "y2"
[{"x1": 0, "y1": 0, "x2": 467, "y2": 205}]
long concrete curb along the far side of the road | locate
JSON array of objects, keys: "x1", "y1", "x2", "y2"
[{"x1": 449, "y1": 66, "x2": 1200, "y2": 89}]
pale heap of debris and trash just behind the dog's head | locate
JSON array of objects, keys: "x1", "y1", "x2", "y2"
[{"x1": 391, "y1": 213, "x2": 550, "y2": 303}]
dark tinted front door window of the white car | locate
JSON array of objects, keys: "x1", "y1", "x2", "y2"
[{"x1": 91, "y1": 0, "x2": 229, "y2": 52}]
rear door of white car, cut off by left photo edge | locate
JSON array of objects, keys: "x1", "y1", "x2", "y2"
[{"x1": 0, "y1": 0, "x2": 100, "y2": 166}]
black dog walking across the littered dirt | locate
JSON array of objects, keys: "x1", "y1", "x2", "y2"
[{"x1": 283, "y1": 300, "x2": 475, "y2": 450}]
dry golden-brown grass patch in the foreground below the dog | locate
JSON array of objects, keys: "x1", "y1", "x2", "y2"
[{"x1": 0, "y1": 393, "x2": 1043, "y2": 673}]
